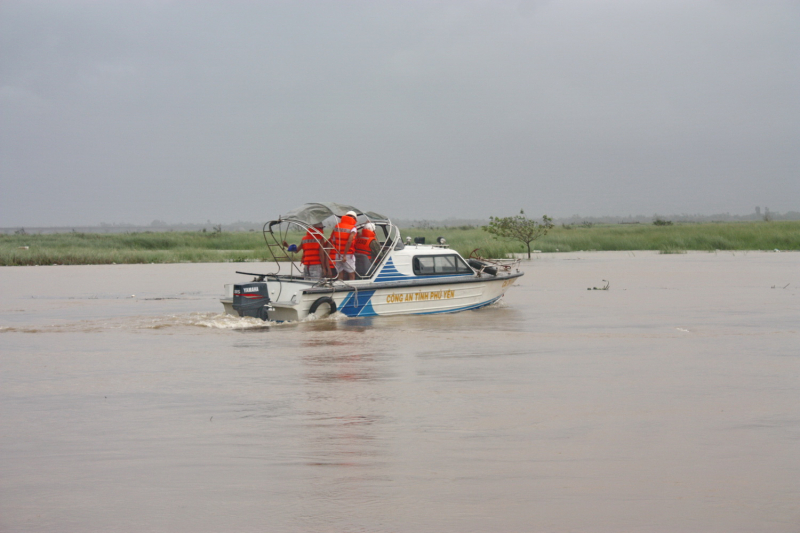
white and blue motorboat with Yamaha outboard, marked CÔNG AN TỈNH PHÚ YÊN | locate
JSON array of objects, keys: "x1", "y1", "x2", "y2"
[{"x1": 221, "y1": 203, "x2": 523, "y2": 322}]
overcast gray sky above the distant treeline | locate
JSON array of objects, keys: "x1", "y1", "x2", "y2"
[{"x1": 0, "y1": 0, "x2": 800, "y2": 227}]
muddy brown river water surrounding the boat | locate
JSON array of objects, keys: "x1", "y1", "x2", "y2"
[{"x1": 0, "y1": 252, "x2": 800, "y2": 533}]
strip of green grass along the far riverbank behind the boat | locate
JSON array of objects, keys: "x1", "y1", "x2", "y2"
[{"x1": 0, "y1": 221, "x2": 800, "y2": 266}]
